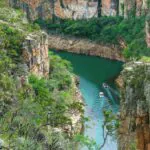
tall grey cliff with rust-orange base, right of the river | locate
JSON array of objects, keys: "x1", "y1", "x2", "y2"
[{"x1": 119, "y1": 62, "x2": 150, "y2": 150}]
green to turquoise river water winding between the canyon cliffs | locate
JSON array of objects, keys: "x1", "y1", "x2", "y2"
[{"x1": 56, "y1": 52, "x2": 122, "y2": 150}]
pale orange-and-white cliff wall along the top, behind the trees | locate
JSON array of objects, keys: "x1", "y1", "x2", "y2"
[{"x1": 9, "y1": 0, "x2": 149, "y2": 20}]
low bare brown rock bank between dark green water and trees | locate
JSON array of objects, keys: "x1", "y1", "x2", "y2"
[{"x1": 48, "y1": 34, "x2": 124, "y2": 61}]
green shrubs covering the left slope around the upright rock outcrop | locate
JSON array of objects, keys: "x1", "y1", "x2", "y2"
[{"x1": 0, "y1": 5, "x2": 83, "y2": 150}]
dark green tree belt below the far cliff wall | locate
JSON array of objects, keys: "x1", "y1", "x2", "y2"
[{"x1": 36, "y1": 16, "x2": 150, "y2": 58}]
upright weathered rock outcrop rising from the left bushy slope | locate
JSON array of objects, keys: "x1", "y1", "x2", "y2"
[{"x1": 23, "y1": 32, "x2": 49, "y2": 77}]
